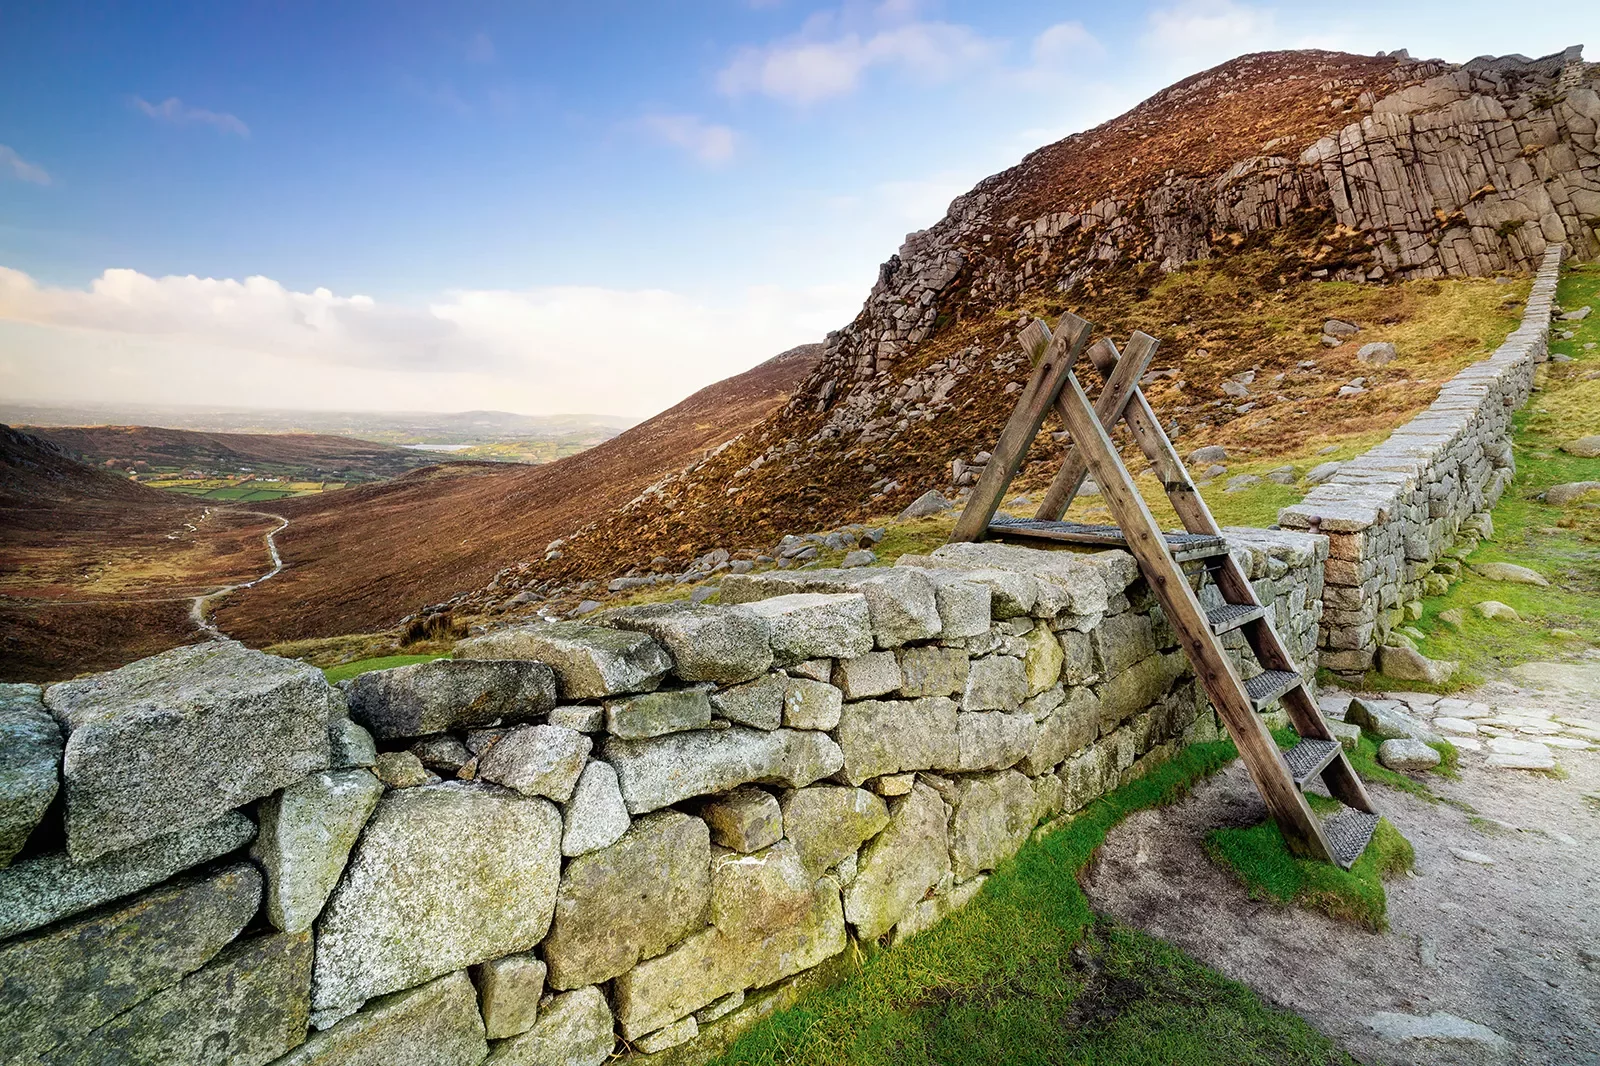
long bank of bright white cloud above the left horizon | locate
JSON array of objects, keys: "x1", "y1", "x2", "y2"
[{"x1": 0, "y1": 267, "x2": 859, "y2": 416}]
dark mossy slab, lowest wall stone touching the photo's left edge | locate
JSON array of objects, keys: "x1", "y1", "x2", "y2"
[{"x1": 0, "y1": 863, "x2": 261, "y2": 1061}]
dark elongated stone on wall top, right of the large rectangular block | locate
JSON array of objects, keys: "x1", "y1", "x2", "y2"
[{"x1": 344, "y1": 659, "x2": 555, "y2": 739}]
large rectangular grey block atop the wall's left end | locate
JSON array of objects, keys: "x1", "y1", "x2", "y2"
[{"x1": 45, "y1": 640, "x2": 330, "y2": 861}]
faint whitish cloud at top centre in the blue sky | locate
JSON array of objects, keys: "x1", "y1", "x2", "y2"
[{"x1": 717, "y1": 0, "x2": 1000, "y2": 104}]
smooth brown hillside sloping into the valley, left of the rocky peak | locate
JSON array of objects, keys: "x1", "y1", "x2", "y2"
[{"x1": 216, "y1": 344, "x2": 821, "y2": 643}]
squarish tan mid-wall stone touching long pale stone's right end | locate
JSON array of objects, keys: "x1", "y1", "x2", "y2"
[{"x1": 837, "y1": 696, "x2": 960, "y2": 784}]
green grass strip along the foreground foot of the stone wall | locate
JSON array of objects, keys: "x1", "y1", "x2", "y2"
[{"x1": 718, "y1": 741, "x2": 1352, "y2": 1066}]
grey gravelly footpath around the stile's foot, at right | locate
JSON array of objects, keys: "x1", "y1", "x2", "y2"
[{"x1": 1085, "y1": 658, "x2": 1600, "y2": 1066}]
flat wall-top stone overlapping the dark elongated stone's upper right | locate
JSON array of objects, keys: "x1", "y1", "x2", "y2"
[{"x1": 454, "y1": 623, "x2": 672, "y2": 699}]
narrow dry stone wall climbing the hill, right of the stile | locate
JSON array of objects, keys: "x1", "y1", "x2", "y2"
[{"x1": 1278, "y1": 245, "x2": 1562, "y2": 677}]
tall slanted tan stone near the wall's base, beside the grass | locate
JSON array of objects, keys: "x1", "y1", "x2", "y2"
[{"x1": 845, "y1": 781, "x2": 950, "y2": 940}]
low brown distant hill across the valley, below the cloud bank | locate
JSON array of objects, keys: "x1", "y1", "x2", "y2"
[{"x1": 27, "y1": 426, "x2": 438, "y2": 479}]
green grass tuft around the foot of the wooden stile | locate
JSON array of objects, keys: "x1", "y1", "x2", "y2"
[{"x1": 1206, "y1": 820, "x2": 1416, "y2": 933}]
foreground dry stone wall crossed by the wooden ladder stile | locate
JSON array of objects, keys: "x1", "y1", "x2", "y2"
[{"x1": 0, "y1": 530, "x2": 1326, "y2": 1066}]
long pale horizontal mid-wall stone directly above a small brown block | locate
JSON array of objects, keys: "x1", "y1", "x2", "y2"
[{"x1": 602, "y1": 725, "x2": 845, "y2": 815}]
